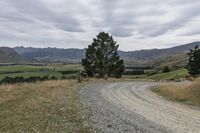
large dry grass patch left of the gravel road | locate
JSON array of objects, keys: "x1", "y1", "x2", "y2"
[{"x1": 0, "y1": 80, "x2": 91, "y2": 133}]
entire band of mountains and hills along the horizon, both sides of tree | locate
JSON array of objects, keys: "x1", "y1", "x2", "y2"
[{"x1": 0, "y1": 42, "x2": 200, "y2": 67}]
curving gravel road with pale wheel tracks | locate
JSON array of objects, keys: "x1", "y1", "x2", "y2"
[{"x1": 80, "y1": 82, "x2": 200, "y2": 133}]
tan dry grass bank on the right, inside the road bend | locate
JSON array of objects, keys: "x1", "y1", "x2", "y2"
[{"x1": 152, "y1": 79, "x2": 200, "y2": 106}]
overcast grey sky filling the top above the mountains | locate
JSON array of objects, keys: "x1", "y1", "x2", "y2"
[{"x1": 0, "y1": 0, "x2": 200, "y2": 51}]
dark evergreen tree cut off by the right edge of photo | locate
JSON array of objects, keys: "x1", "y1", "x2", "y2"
[{"x1": 186, "y1": 46, "x2": 200, "y2": 75}]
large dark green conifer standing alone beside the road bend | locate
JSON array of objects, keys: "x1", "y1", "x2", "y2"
[{"x1": 82, "y1": 32, "x2": 124, "y2": 78}]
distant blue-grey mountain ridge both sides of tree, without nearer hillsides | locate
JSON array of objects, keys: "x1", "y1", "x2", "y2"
[{"x1": 14, "y1": 42, "x2": 200, "y2": 65}]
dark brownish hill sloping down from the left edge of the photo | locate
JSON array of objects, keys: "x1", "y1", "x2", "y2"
[{"x1": 0, "y1": 47, "x2": 26, "y2": 63}]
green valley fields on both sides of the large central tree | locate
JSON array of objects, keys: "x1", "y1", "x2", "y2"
[{"x1": 0, "y1": 64, "x2": 188, "y2": 80}]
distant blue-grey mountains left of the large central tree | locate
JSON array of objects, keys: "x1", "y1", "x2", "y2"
[{"x1": 14, "y1": 47, "x2": 85, "y2": 63}]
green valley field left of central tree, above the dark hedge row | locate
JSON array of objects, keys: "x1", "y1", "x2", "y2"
[{"x1": 0, "y1": 64, "x2": 83, "y2": 80}]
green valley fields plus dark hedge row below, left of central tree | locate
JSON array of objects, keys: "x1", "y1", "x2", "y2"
[{"x1": 0, "y1": 64, "x2": 83, "y2": 83}]
